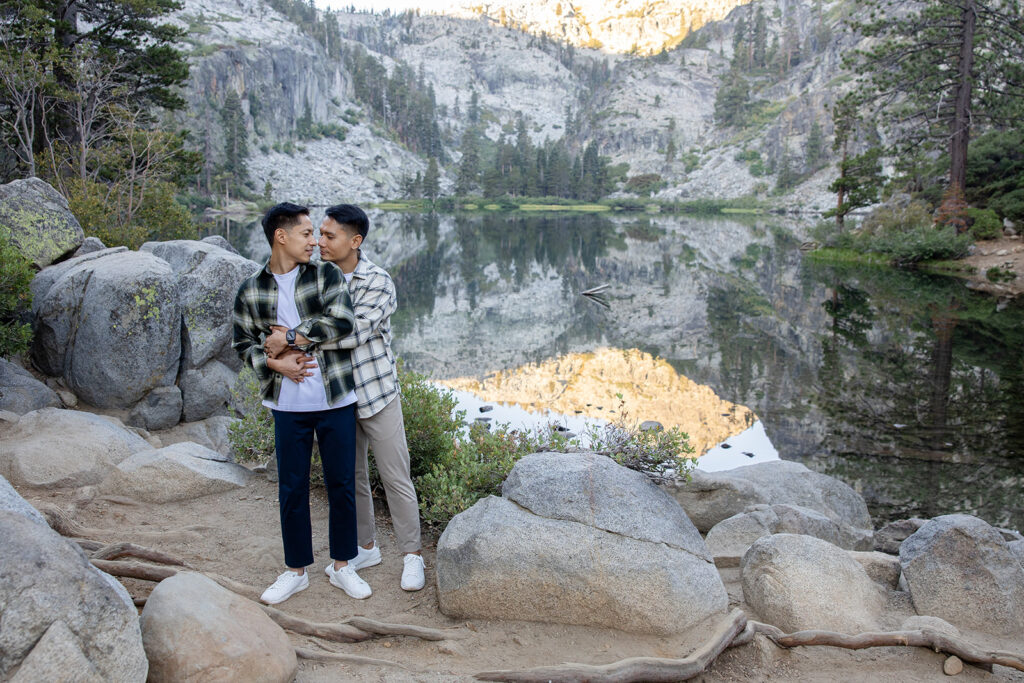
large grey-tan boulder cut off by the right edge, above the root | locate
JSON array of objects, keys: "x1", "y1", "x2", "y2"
[{"x1": 899, "y1": 515, "x2": 1024, "y2": 637}]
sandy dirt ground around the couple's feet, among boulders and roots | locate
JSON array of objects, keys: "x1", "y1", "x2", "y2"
[{"x1": 20, "y1": 476, "x2": 1024, "y2": 683}]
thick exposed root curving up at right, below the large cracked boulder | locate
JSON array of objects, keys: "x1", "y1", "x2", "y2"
[{"x1": 476, "y1": 609, "x2": 746, "y2": 683}]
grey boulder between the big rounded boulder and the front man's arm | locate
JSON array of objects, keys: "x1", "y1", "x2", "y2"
[{"x1": 140, "y1": 240, "x2": 260, "y2": 370}]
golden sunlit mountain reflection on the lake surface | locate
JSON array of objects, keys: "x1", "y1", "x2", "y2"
[{"x1": 441, "y1": 348, "x2": 757, "y2": 455}]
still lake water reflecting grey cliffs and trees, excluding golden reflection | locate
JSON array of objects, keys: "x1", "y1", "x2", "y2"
[{"x1": 207, "y1": 212, "x2": 1024, "y2": 529}]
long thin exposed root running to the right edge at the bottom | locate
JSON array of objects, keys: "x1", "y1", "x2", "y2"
[{"x1": 749, "y1": 622, "x2": 1024, "y2": 671}]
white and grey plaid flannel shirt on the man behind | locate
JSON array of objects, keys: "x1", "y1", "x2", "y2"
[{"x1": 324, "y1": 252, "x2": 398, "y2": 419}]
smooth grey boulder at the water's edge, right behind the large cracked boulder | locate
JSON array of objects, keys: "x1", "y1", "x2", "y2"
[{"x1": 673, "y1": 460, "x2": 872, "y2": 536}]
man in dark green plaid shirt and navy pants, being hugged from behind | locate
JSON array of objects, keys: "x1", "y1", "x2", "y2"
[{"x1": 231, "y1": 203, "x2": 371, "y2": 604}]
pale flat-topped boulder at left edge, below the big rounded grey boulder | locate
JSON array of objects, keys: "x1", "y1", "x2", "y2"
[{"x1": 0, "y1": 408, "x2": 151, "y2": 488}]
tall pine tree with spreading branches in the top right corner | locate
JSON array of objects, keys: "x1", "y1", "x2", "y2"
[{"x1": 848, "y1": 0, "x2": 1024, "y2": 197}]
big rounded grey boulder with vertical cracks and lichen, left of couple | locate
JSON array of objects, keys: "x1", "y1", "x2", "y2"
[{"x1": 32, "y1": 252, "x2": 181, "y2": 408}]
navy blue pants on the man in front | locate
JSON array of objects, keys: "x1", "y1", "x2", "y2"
[{"x1": 272, "y1": 403, "x2": 356, "y2": 569}]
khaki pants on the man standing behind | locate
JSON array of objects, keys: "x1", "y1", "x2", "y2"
[{"x1": 355, "y1": 396, "x2": 421, "y2": 553}]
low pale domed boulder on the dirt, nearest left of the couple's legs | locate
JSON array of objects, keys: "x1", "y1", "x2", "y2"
[{"x1": 100, "y1": 441, "x2": 251, "y2": 503}]
